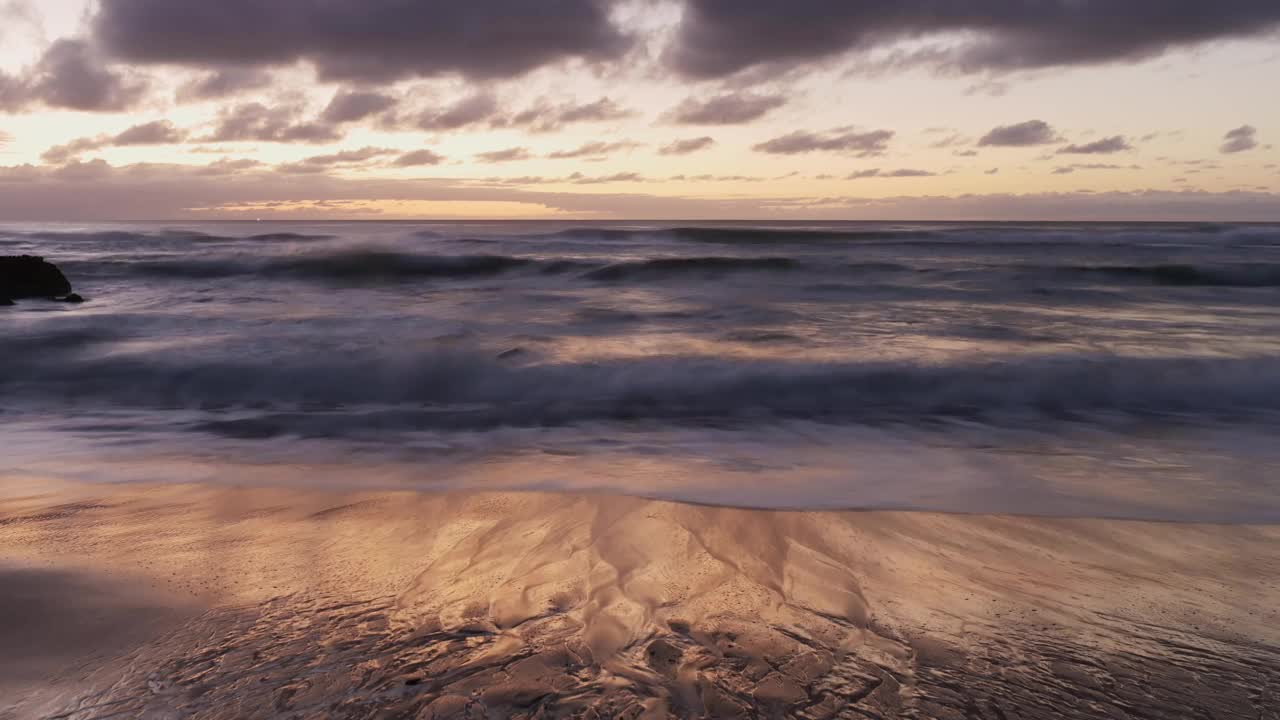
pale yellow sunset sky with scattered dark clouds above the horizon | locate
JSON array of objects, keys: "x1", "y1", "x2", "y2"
[{"x1": 0, "y1": 0, "x2": 1280, "y2": 222}]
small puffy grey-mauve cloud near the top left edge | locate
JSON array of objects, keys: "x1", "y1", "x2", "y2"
[{"x1": 0, "y1": 38, "x2": 147, "y2": 113}]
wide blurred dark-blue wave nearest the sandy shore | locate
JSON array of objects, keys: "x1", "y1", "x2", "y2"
[{"x1": 0, "y1": 343, "x2": 1280, "y2": 429}]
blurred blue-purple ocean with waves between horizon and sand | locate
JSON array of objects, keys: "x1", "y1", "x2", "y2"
[{"x1": 0, "y1": 222, "x2": 1280, "y2": 523}]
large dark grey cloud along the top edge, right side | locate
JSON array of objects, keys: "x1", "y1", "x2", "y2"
[{"x1": 667, "y1": 0, "x2": 1280, "y2": 78}]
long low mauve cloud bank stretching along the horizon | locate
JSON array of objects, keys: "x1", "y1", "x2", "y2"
[{"x1": 0, "y1": 160, "x2": 1280, "y2": 222}]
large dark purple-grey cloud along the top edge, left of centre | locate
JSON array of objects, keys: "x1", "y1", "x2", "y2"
[{"x1": 92, "y1": 0, "x2": 630, "y2": 82}]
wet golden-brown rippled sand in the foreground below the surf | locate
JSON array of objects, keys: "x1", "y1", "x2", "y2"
[{"x1": 0, "y1": 478, "x2": 1280, "y2": 720}]
